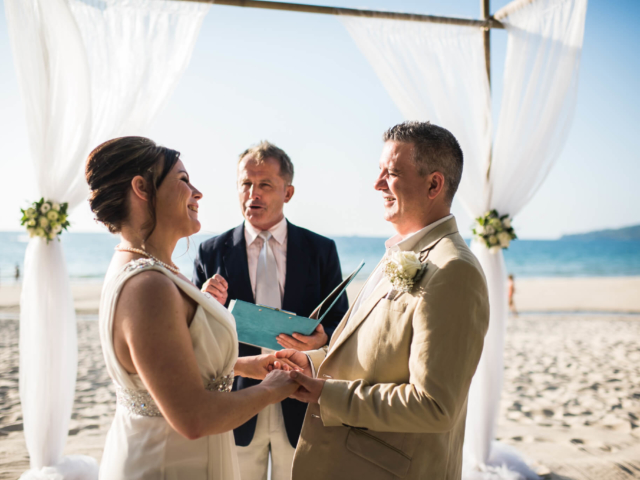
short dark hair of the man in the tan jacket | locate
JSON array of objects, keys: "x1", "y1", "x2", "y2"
[{"x1": 383, "y1": 122, "x2": 463, "y2": 204}]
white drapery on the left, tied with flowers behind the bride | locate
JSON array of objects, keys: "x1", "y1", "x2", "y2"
[{"x1": 5, "y1": 0, "x2": 208, "y2": 480}]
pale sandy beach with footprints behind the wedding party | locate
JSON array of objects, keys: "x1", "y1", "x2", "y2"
[{"x1": 0, "y1": 277, "x2": 640, "y2": 480}]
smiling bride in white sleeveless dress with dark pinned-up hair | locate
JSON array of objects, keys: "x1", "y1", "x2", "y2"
[{"x1": 86, "y1": 137, "x2": 297, "y2": 480}]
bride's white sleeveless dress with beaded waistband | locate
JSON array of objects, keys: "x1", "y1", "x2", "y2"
[{"x1": 100, "y1": 259, "x2": 240, "y2": 480}]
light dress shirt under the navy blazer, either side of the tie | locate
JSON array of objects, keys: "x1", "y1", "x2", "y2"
[{"x1": 244, "y1": 217, "x2": 289, "y2": 302}]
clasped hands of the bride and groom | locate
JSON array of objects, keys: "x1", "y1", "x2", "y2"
[{"x1": 235, "y1": 349, "x2": 325, "y2": 403}]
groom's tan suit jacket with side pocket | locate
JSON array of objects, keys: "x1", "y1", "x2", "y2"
[{"x1": 293, "y1": 218, "x2": 489, "y2": 480}]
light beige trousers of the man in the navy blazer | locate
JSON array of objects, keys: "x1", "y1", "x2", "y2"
[{"x1": 236, "y1": 403, "x2": 296, "y2": 480}]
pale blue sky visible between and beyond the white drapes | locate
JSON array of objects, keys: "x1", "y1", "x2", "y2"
[{"x1": 0, "y1": 0, "x2": 640, "y2": 238}]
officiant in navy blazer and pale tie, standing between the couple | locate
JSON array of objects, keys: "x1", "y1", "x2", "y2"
[{"x1": 193, "y1": 142, "x2": 348, "y2": 480}]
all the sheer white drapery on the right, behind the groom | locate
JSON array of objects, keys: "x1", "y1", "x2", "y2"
[{"x1": 341, "y1": 0, "x2": 587, "y2": 480}]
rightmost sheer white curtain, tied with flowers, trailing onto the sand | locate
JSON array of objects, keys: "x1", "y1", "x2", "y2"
[{"x1": 465, "y1": 0, "x2": 587, "y2": 479}]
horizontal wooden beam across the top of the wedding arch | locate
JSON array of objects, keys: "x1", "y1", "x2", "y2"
[{"x1": 177, "y1": 0, "x2": 504, "y2": 30}]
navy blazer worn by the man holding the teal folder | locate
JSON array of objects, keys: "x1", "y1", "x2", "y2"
[{"x1": 193, "y1": 221, "x2": 349, "y2": 447}]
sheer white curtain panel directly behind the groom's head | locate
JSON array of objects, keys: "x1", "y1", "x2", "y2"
[{"x1": 340, "y1": 16, "x2": 492, "y2": 217}]
